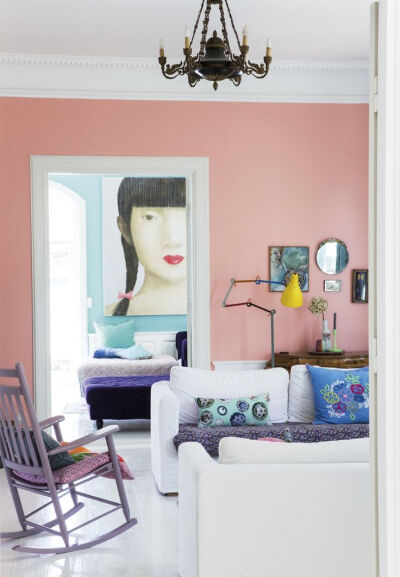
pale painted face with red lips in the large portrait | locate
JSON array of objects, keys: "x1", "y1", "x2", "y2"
[{"x1": 130, "y1": 206, "x2": 186, "y2": 283}]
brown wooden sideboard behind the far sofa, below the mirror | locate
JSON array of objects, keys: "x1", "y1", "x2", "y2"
[{"x1": 275, "y1": 352, "x2": 368, "y2": 370}]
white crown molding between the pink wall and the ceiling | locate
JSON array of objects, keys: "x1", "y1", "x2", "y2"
[{"x1": 0, "y1": 54, "x2": 368, "y2": 103}]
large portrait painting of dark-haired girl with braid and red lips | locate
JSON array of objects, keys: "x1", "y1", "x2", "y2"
[{"x1": 102, "y1": 176, "x2": 187, "y2": 316}]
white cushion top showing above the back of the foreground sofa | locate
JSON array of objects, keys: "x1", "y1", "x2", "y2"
[{"x1": 219, "y1": 437, "x2": 369, "y2": 465}]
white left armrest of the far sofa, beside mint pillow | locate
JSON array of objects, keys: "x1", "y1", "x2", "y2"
[{"x1": 151, "y1": 381, "x2": 179, "y2": 493}]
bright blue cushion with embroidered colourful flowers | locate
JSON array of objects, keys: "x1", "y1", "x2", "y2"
[{"x1": 306, "y1": 365, "x2": 369, "y2": 424}]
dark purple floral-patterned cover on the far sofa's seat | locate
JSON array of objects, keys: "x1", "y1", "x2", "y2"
[{"x1": 174, "y1": 423, "x2": 369, "y2": 457}]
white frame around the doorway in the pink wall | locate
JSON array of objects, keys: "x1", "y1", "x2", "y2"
[{"x1": 31, "y1": 156, "x2": 210, "y2": 419}]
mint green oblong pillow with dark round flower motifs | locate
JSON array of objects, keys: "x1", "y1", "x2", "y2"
[{"x1": 196, "y1": 393, "x2": 270, "y2": 427}]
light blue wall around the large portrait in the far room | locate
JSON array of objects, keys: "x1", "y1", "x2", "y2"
[{"x1": 50, "y1": 174, "x2": 186, "y2": 332}]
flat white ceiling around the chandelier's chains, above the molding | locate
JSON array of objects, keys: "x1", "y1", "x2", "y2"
[{"x1": 0, "y1": 0, "x2": 371, "y2": 60}]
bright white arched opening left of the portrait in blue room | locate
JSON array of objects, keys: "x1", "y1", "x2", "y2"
[{"x1": 49, "y1": 180, "x2": 87, "y2": 415}]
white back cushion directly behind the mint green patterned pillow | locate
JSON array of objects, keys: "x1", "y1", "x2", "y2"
[{"x1": 170, "y1": 367, "x2": 289, "y2": 423}]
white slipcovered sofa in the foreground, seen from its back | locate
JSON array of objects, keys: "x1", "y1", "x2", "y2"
[{"x1": 179, "y1": 438, "x2": 370, "y2": 577}]
